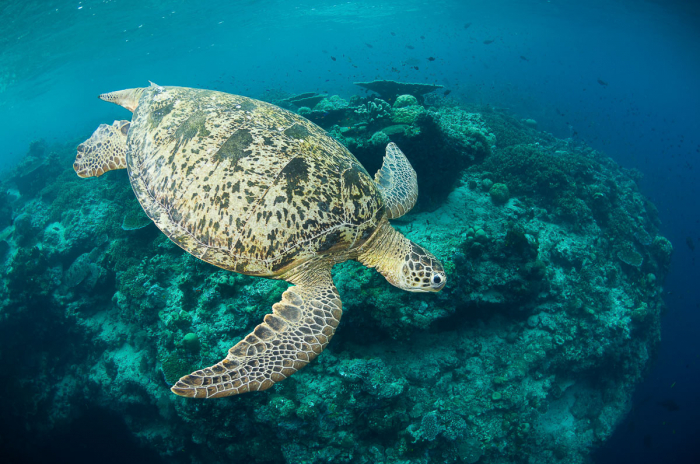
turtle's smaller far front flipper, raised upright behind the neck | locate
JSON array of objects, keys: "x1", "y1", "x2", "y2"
[{"x1": 374, "y1": 142, "x2": 418, "y2": 219}]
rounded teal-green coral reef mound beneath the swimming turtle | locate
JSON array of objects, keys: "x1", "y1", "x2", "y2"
[{"x1": 0, "y1": 88, "x2": 673, "y2": 463}]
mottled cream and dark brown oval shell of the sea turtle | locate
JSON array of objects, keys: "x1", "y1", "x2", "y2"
[{"x1": 127, "y1": 85, "x2": 384, "y2": 276}]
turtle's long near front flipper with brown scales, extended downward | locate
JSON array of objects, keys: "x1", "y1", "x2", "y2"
[{"x1": 171, "y1": 264, "x2": 342, "y2": 398}]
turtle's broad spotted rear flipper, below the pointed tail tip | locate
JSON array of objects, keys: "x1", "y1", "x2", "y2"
[{"x1": 73, "y1": 120, "x2": 131, "y2": 177}]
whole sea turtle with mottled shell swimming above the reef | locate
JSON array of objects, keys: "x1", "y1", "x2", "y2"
[{"x1": 73, "y1": 84, "x2": 446, "y2": 398}]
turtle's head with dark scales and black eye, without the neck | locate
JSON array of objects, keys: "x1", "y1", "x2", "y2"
[{"x1": 396, "y1": 239, "x2": 447, "y2": 292}]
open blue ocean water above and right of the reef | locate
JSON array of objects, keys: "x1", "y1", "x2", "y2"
[{"x1": 0, "y1": 0, "x2": 700, "y2": 463}]
